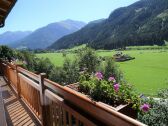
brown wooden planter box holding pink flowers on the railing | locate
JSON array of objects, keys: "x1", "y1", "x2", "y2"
[{"x1": 65, "y1": 83, "x2": 138, "y2": 119}]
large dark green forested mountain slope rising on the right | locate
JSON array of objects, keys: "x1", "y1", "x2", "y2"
[{"x1": 48, "y1": 0, "x2": 168, "y2": 49}]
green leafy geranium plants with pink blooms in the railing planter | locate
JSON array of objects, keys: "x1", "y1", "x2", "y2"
[{"x1": 79, "y1": 74, "x2": 139, "y2": 109}]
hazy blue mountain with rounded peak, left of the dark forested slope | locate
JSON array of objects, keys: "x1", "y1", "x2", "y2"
[{"x1": 11, "y1": 20, "x2": 85, "y2": 49}]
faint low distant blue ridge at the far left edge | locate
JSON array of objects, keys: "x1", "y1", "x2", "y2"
[{"x1": 0, "y1": 31, "x2": 31, "y2": 45}]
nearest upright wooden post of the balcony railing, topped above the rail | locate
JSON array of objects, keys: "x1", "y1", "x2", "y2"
[{"x1": 39, "y1": 73, "x2": 49, "y2": 126}]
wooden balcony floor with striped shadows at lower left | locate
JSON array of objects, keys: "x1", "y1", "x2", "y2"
[{"x1": 0, "y1": 76, "x2": 40, "y2": 126}]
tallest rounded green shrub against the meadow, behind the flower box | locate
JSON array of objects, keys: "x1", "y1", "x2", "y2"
[{"x1": 79, "y1": 48, "x2": 100, "y2": 73}]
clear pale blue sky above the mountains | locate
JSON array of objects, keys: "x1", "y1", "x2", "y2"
[{"x1": 0, "y1": 0, "x2": 138, "y2": 33}]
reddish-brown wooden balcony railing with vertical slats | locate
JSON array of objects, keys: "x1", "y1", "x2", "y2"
[{"x1": 0, "y1": 61, "x2": 145, "y2": 126}]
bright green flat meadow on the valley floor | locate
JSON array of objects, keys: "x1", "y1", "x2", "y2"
[{"x1": 37, "y1": 50, "x2": 168, "y2": 95}]
